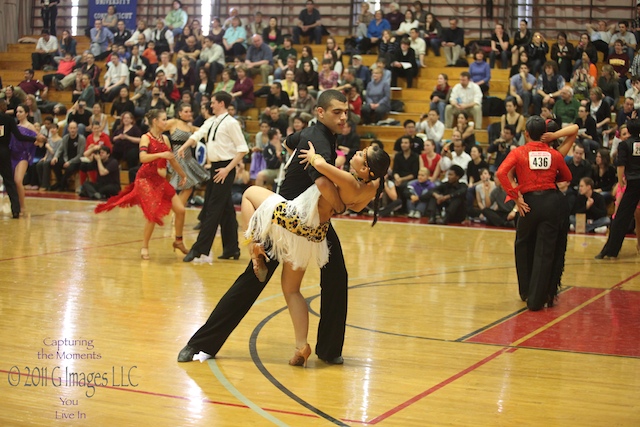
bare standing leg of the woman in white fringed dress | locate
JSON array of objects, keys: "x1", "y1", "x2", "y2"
[{"x1": 281, "y1": 263, "x2": 309, "y2": 349}]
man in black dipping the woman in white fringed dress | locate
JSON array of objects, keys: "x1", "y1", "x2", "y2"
[{"x1": 178, "y1": 90, "x2": 348, "y2": 364}]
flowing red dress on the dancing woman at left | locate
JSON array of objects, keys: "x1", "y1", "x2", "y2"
[{"x1": 95, "y1": 133, "x2": 176, "y2": 225}]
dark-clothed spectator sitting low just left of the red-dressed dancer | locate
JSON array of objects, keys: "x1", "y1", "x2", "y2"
[{"x1": 80, "y1": 145, "x2": 120, "y2": 200}]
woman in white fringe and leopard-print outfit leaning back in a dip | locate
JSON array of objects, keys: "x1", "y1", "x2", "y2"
[{"x1": 242, "y1": 142, "x2": 390, "y2": 366}]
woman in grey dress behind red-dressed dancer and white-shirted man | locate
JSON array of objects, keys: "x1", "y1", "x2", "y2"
[{"x1": 166, "y1": 102, "x2": 210, "y2": 211}]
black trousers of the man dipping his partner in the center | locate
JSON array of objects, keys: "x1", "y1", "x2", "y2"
[{"x1": 189, "y1": 226, "x2": 348, "y2": 360}]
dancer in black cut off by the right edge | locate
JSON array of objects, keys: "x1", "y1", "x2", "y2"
[{"x1": 596, "y1": 119, "x2": 640, "y2": 259}]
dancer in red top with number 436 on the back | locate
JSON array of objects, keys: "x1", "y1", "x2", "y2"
[{"x1": 496, "y1": 116, "x2": 571, "y2": 311}]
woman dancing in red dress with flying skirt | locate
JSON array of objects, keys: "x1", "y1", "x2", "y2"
[{"x1": 95, "y1": 110, "x2": 188, "y2": 260}]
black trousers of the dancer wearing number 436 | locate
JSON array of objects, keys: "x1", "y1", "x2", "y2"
[{"x1": 515, "y1": 190, "x2": 569, "y2": 311}]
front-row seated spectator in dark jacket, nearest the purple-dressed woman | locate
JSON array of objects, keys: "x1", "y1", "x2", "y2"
[{"x1": 51, "y1": 121, "x2": 87, "y2": 191}]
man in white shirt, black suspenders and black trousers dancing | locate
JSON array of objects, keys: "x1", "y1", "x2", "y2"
[{"x1": 178, "y1": 92, "x2": 249, "y2": 262}]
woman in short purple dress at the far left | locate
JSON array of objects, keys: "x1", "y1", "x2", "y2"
[{"x1": 9, "y1": 104, "x2": 42, "y2": 214}]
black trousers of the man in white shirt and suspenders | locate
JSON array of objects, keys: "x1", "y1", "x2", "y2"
[{"x1": 191, "y1": 160, "x2": 239, "y2": 256}]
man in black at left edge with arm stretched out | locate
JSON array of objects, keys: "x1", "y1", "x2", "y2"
[{"x1": 0, "y1": 99, "x2": 45, "y2": 218}]
